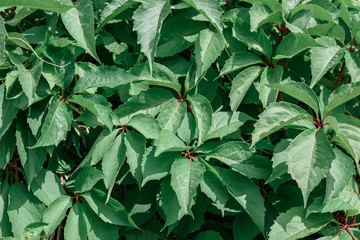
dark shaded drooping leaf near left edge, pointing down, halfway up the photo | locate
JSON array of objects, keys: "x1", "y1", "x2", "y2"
[{"x1": 16, "y1": 121, "x2": 47, "y2": 187}]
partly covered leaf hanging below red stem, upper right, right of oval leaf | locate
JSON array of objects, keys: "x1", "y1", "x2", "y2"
[{"x1": 259, "y1": 65, "x2": 284, "y2": 107}]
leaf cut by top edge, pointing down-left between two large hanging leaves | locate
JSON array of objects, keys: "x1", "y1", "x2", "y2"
[{"x1": 95, "y1": 0, "x2": 136, "y2": 32}]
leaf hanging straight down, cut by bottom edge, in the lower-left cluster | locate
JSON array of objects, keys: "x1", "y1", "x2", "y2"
[{"x1": 64, "y1": 202, "x2": 89, "y2": 240}]
